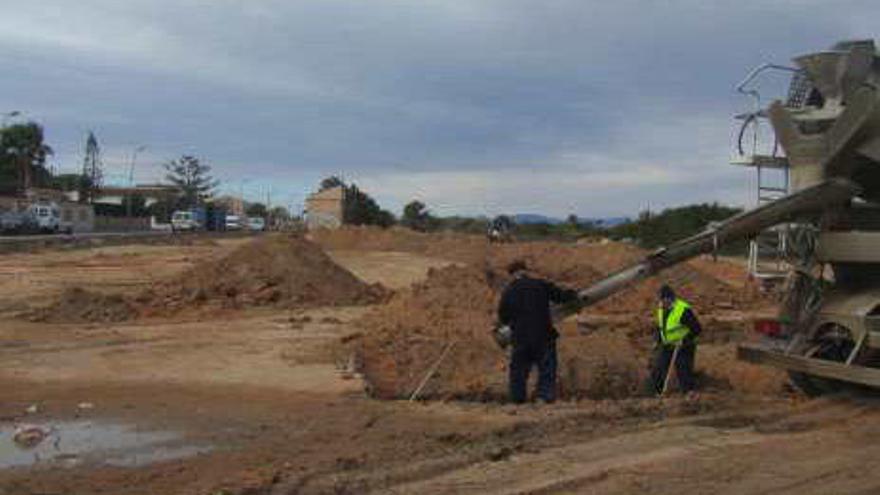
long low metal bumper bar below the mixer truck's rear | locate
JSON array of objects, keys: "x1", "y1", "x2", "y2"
[{"x1": 736, "y1": 344, "x2": 880, "y2": 388}]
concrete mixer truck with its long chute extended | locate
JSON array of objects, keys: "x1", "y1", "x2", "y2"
[{"x1": 580, "y1": 40, "x2": 880, "y2": 394}]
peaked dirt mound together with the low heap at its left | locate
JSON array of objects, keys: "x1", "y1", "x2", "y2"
[{"x1": 34, "y1": 236, "x2": 388, "y2": 322}]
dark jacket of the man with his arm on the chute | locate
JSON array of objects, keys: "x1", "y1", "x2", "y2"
[{"x1": 498, "y1": 276, "x2": 577, "y2": 347}]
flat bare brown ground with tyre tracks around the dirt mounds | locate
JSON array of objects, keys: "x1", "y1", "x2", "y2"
[{"x1": 0, "y1": 233, "x2": 880, "y2": 495}]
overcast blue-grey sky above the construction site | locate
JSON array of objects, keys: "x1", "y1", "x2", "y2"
[{"x1": 0, "y1": 0, "x2": 880, "y2": 217}]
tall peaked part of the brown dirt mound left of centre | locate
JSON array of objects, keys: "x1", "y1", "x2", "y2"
[{"x1": 139, "y1": 236, "x2": 386, "y2": 310}]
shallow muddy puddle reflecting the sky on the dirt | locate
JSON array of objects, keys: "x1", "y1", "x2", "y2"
[{"x1": 0, "y1": 421, "x2": 211, "y2": 469}]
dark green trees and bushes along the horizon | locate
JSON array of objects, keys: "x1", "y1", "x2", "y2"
[{"x1": 0, "y1": 122, "x2": 740, "y2": 244}]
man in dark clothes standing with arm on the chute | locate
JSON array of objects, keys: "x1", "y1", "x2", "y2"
[{"x1": 498, "y1": 261, "x2": 577, "y2": 403}]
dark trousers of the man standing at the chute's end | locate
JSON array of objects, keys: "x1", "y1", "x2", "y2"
[{"x1": 509, "y1": 339, "x2": 556, "y2": 404}]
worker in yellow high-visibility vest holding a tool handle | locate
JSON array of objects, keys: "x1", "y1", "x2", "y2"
[{"x1": 648, "y1": 285, "x2": 702, "y2": 395}]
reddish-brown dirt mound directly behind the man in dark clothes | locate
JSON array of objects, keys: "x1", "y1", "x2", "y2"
[{"x1": 358, "y1": 266, "x2": 644, "y2": 400}]
